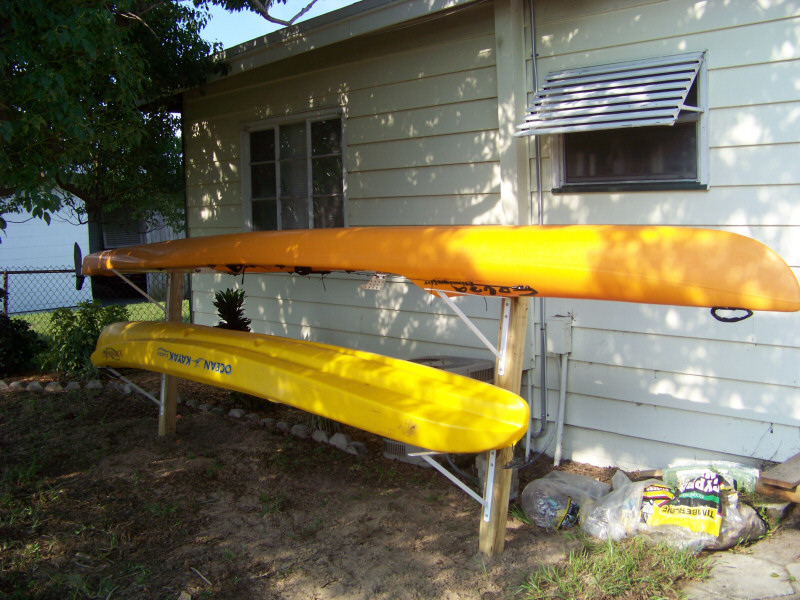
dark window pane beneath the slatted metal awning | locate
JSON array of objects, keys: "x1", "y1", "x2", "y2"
[{"x1": 564, "y1": 122, "x2": 697, "y2": 184}]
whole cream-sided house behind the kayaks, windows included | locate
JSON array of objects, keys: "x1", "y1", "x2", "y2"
[{"x1": 183, "y1": 0, "x2": 800, "y2": 469}]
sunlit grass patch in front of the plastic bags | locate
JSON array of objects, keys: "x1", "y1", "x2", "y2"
[{"x1": 515, "y1": 537, "x2": 709, "y2": 600}]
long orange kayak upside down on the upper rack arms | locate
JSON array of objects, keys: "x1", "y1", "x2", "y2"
[{"x1": 82, "y1": 225, "x2": 800, "y2": 311}]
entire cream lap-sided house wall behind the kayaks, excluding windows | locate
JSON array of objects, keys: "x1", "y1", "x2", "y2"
[{"x1": 184, "y1": 0, "x2": 800, "y2": 469}]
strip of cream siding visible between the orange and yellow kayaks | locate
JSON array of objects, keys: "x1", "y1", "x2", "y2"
[{"x1": 193, "y1": 274, "x2": 510, "y2": 358}]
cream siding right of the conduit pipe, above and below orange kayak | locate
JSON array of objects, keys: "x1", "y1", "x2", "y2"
[{"x1": 532, "y1": 0, "x2": 800, "y2": 468}]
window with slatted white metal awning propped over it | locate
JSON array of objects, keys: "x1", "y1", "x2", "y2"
[{"x1": 518, "y1": 53, "x2": 708, "y2": 192}]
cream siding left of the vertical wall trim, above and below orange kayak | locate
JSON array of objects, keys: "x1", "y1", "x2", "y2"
[{"x1": 185, "y1": 4, "x2": 500, "y2": 358}]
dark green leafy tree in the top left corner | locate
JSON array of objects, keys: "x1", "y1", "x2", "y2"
[{"x1": 0, "y1": 0, "x2": 224, "y2": 238}]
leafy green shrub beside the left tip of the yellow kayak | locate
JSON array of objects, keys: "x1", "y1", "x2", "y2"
[{"x1": 46, "y1": 301, "x2": 128, "y2": 379}]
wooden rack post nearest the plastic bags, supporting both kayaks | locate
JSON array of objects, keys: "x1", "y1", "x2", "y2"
[{"x1": 479, "y1": 298, "x2": 529, "y2": 556}]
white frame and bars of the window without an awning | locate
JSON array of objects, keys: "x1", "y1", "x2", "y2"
[{"x1": 239, "y1": 107, "x2": 349, "y2": 231}]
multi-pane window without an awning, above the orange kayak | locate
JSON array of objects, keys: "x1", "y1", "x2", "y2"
[{"x1": 242, "y1": 115, "x2": 346, "y2": 230}]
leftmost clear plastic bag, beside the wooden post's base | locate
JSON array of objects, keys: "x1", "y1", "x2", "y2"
[{"x1": 521, "y1": 471, "x2": 611, "y2": 530}]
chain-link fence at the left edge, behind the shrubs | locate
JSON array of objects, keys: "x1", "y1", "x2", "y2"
[{"x1": 0, "y1": 266, "x2": 190, "y2": 335}]
